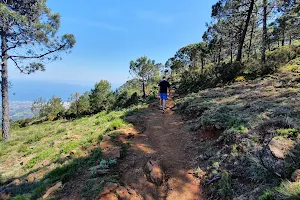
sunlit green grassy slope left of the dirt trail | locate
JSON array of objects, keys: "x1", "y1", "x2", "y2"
[{"x1": 0, "y1": 105, "x2": 143, "y2": 199}]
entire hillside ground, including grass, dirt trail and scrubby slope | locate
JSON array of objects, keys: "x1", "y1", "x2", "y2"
[{"x1": 0, "y1": 59, "x2": 300, "y2": 200}]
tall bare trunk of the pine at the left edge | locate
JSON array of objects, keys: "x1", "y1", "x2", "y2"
[{"x1": 1, "y1": 32, "x2": 10, "y2": 140}]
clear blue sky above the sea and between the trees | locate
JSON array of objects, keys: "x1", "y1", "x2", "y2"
[{"x1": 10, "y1": 0, "x2": 216, "y2": 100}]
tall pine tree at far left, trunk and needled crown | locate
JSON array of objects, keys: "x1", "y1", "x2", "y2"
[{"x1": 0, "y1": 0, "x2": 75, "y2": 140}]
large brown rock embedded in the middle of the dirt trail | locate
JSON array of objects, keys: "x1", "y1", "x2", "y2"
[{"x1": 146, "y1": 160, "x2": 164, "y2": 186}]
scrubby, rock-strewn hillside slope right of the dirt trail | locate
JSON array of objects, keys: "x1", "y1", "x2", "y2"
[{"x1": 176, "y1": 58, "x2": 300, "y2": 199}]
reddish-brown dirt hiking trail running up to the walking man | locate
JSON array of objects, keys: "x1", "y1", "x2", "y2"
[{"x1": 120, "y1": 100, "x2": 203, "y2": 200}]
